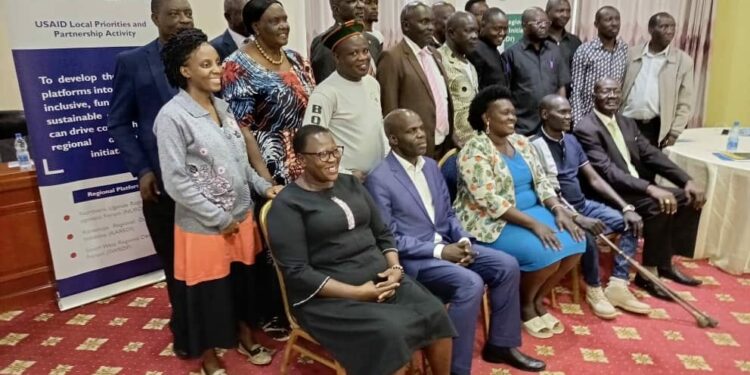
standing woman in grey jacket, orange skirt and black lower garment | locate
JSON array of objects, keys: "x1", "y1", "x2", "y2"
[{"x1": 154, "y1": 29, "x2": 280, "y2": 375}]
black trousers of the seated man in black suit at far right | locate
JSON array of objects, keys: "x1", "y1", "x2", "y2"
[{"x1": 624, "y1": 186, "x2": 700, "y2": 268}]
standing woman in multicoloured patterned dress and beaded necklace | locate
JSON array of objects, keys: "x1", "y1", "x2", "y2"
[{"x1": 222, "y1": 0, "x2": 315, "y2": 184}]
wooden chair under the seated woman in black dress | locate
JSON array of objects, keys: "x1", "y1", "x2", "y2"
[{"x1": 259, "y1": 201, "x2": 346, "y2": 375}]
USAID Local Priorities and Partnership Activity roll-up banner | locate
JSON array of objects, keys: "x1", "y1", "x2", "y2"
[{"x1": 0, "y1": 0, "x2": 164, "y2": 310}]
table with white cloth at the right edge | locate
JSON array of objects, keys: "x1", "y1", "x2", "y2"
[{"x1": 664, "y1": 128, "x2": 750, "y2": 274}]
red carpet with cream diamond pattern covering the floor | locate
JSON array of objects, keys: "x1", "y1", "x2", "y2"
[{"x1": 0, "y1": 261, "x2": 750, "y2": 375}]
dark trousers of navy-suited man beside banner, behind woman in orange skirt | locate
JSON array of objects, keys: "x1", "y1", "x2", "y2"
[{"x1": 143, "y1": 195, "x2": 188, "y2": 357}]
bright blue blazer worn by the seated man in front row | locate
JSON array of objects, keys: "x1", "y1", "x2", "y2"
[{"x1": 365, "y1": 151, "x2": 472, "y2": 277}]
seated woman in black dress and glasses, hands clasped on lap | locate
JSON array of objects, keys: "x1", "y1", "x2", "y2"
[{"x1": 268, "y1": 125, "x2": 455, "y2": 375}]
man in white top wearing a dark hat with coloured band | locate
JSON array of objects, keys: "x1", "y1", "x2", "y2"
[{"x1": 302, "y1": 21, "x2": 388, "y2": 180}]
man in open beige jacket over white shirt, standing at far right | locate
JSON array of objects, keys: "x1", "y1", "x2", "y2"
[{"x1": 621, "y1": 12, "x2": 694, "y2": 148}]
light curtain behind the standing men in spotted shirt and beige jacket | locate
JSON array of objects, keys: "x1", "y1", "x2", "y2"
[{"x1": 574, "y1": 0, "x2": 716, "y2": 127}]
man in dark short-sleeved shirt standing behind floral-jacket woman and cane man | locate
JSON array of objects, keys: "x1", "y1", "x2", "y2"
[{"x1": 501, "y1": 8, "x2": 570, "y2": 136}]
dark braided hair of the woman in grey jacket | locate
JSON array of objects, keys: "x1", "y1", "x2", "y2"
[{"x1": 161, "y1": 29, "x2": 208, "y2": 89}]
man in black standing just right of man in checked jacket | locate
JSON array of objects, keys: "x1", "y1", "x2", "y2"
[{"x1": 469, "y1": 8, "x2": 508, "y2": 90}]
